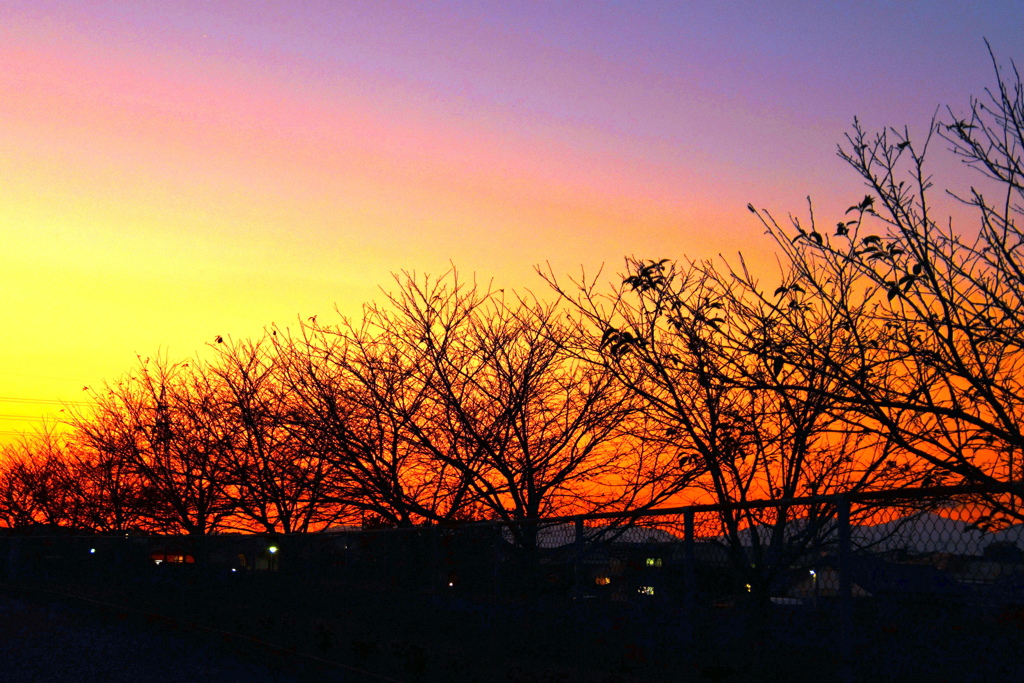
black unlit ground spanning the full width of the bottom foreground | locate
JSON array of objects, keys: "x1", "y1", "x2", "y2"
[{"x1": 0, "y1": 582, "x2": 1024, "y2": 683}]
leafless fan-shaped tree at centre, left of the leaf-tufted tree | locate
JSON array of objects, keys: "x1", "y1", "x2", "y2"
[{"x1": 368, "y1": 270, "x2": 668, "y2": 546}]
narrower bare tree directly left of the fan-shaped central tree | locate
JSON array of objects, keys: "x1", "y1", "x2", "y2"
[{"x1": 274, "y1": 321, "x2": 466, "y2": 526}]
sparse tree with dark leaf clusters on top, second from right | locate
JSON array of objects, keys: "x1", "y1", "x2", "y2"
[{"x1": 545, "y1": 259, "x2": 918, "y2": 600}]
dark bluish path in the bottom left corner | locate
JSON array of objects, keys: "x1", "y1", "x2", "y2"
[{"x1": 0, "y1": 595, "x2": 299, "y2": 683}]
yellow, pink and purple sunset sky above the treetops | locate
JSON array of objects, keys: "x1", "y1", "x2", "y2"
[{"x1": 0, "y1": 0, "x2": 1024, "y2": 439}]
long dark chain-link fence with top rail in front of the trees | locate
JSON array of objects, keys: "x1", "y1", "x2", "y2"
[{"x1": 0, "y1": 488, "x2": 1024, "y2": 681}]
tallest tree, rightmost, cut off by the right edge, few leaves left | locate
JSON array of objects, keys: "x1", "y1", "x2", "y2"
[{"x1": 751, "y1": 46, "x2": 1024, "y2": 518}]
